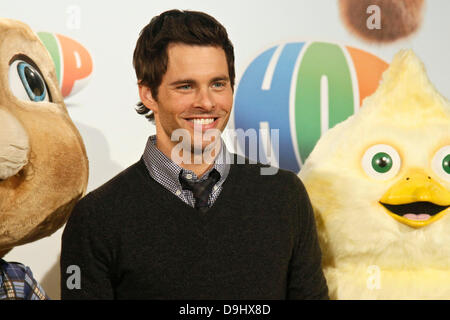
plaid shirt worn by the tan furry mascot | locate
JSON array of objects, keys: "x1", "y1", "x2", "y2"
[{"x1": 0, "y1": 259, "x2": 49, "y2": 300}]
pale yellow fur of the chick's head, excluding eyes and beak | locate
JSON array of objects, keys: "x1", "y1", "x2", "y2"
[{"x1": 299, "y1": 50, "x2": 450, "y2": 268}]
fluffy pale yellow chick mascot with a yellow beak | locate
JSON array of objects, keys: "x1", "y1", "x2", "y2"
[{"x1": 299, "y1": 50, "x2": 450, "y2": 299}]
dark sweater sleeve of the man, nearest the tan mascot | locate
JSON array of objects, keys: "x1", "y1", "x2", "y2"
[{"x1": 60, "y1": 196, "x2": 114, "y2": 299}]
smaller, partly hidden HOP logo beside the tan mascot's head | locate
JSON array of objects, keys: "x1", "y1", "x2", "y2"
[{"x1": 38, "y1": 32, "x2": 93, "y2": 98}]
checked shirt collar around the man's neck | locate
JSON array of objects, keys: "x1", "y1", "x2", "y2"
[{"x1": 142, "y1": 135, "x2": 231, "y2": 207}]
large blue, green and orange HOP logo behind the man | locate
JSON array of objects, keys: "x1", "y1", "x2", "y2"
[{"x1": 234, "y1": 42, "x2": 388, "y2": 172}]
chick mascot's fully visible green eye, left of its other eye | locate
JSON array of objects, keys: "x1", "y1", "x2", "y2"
[{"x1": 361, "y1": 144, "x2": 401, "y2": 180}]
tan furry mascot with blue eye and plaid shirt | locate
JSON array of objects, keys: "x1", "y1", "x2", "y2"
[{"x1": 0, "y1": 19, "x2": 88, "y2": 299}]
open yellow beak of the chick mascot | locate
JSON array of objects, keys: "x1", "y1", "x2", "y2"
[{"x1": 380, "y1": 169, "x2": 450, "y2": 228}]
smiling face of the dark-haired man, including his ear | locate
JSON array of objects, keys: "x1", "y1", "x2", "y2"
[{"x1": 140, "y1": 43, "x2": 234, "y2": 176}]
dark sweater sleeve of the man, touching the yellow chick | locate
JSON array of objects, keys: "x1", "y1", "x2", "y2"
[{"x1": 287, "y1": 176, "x2": 329, "y2": 300}]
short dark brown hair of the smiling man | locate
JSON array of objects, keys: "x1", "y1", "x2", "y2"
[{"x1": 133, "y1": 10, "x2": 235, "y2": 121}]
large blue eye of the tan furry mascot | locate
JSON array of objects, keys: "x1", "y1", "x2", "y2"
[{"x1": 8, "y1": 60, "x2": 49, "y2": 102}]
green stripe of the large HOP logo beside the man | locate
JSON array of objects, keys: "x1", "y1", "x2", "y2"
[{"x1": 294, "y1": 42, "x2": 354, "y2": 162}]
